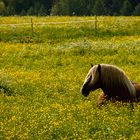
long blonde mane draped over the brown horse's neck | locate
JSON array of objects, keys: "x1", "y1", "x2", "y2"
[{"x1": 92, "y1": 64, "x2": 136, "y2": 98}]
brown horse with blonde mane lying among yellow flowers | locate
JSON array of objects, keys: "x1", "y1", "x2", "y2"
[{"x1": 81, "y1": 64, "x2": 140, "y2": 105}]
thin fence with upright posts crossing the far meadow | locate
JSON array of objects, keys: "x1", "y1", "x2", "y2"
[{"x1": 0, "y1": 16, "x2": 140, "y2": 42}]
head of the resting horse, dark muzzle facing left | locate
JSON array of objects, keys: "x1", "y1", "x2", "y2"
[{"x1": 81, "y1": 64, "x2": 101, "y2": 96}]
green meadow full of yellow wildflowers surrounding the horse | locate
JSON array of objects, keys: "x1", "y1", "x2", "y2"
[{"x1": 0, "y1": 17, "x2": 140, "y2": 140}]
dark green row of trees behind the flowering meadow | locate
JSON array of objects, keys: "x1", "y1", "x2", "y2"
[{"x1": 0, "y1": 0, "x2": 140, "y2": 16}]
